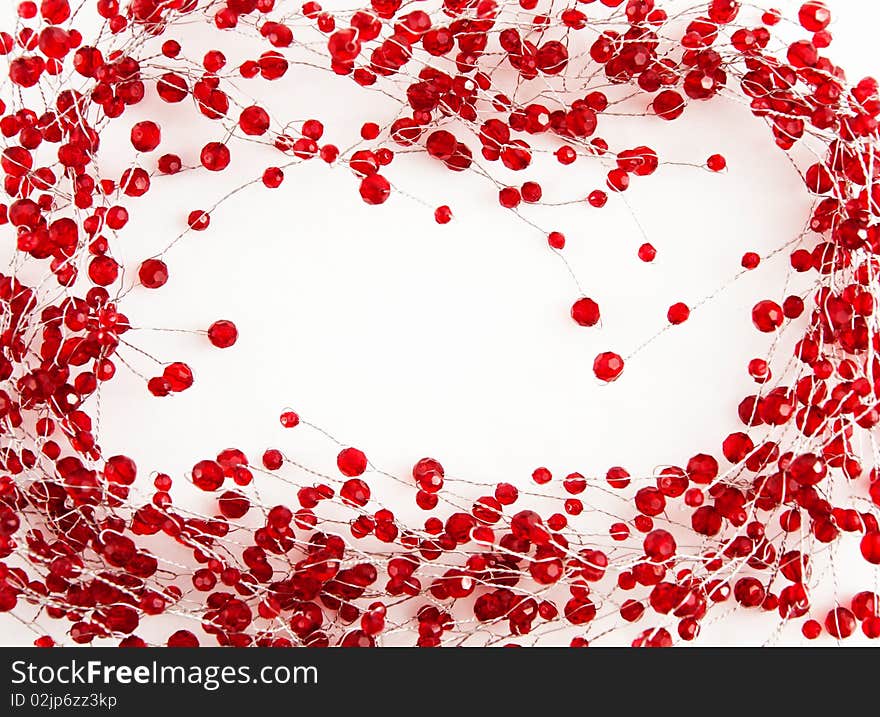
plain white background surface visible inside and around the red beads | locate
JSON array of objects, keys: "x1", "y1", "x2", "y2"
[{"x1": 0, "y1": 0, "x2": 880, "y2": 644}]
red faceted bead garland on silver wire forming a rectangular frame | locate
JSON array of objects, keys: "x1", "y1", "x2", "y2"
[{"x1": 0, "y1": 0, "x2": 880, "y2": 647}]
